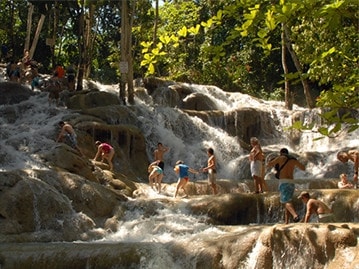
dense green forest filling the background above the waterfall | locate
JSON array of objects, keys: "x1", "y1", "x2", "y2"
[{"x1": 0, "y1": 0, "x2": 359, "y2": 135}]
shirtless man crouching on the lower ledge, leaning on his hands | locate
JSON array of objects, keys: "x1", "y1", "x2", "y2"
[{"x1": 298, "y1": 191, "x2": 334, "y2": 223}]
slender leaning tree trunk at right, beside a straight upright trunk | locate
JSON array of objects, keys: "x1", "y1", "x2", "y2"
[{"x1": 283, "y1": 24, "x2": 314, "y2": 108}]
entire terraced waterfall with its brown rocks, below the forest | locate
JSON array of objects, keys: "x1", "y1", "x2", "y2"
[{"x1": 0, "y1": 72, "x2": 359, "y2": 269}]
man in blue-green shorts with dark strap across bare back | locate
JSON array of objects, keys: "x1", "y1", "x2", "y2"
[{"x1": 267, "y1": 148, "x2": 305, "y2": 224}]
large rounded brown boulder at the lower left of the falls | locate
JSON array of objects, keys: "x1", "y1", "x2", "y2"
[{"x1": 0, "y1": 170, "x2": 127, "y2": 242}]
